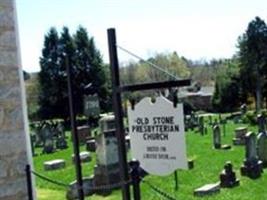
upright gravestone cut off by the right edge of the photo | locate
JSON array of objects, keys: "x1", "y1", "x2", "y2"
[{"x1": 258, "y1": 132, "x2": 267, "y2": 167}]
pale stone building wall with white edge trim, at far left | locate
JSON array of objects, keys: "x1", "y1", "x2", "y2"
[{"x1": 0, "y1": 0, "x2": 34, "y2": 200}]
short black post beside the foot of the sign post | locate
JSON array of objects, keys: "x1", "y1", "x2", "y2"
[{"x1": 130, "y1": 160, "x2": 141, "y2": 200}]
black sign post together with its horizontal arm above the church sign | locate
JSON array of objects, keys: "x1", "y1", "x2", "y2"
[{"x1": 107, "y1": 28, "x2": 191, "y2": 200}]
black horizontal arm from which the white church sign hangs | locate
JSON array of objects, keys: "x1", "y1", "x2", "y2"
[{"x1": 118, "y1": 79, "x2": 191, "y2": 92}]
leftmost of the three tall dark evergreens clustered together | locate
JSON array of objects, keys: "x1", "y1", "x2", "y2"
[{"x1": 38, "y1": 28, "x2": 63, "y2": 119}]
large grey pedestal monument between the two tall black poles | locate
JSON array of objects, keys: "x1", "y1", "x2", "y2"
[{"x1": 94, "y1": 115, "x2": 121, "y2": 194}]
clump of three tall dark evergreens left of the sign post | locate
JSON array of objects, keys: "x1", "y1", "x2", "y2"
[{"x1": 39, "y1": 27, "x2": 108, "y2": 119}]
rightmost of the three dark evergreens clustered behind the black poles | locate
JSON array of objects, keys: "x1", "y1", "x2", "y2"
[{"x1": 74, "y1": 27, "x2": 112, "y2": 113}]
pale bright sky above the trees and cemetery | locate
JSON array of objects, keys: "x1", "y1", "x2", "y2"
[{"x1": 16, "y1": 0, "x2": 267, "y2": 72}]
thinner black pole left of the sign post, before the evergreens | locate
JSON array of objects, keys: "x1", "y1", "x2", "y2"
[{"x1": 65, "y1": 55, "x2": 84, "y2": 200}]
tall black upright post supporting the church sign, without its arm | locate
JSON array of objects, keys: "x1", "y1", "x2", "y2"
[{"x1": 107, "y1": 28, "x2": 130, "y2": 200}]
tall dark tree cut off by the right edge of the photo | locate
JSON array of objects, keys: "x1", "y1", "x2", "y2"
[{"x1": 238, "y1": 17, "x2": 267, "y2": 111}]
